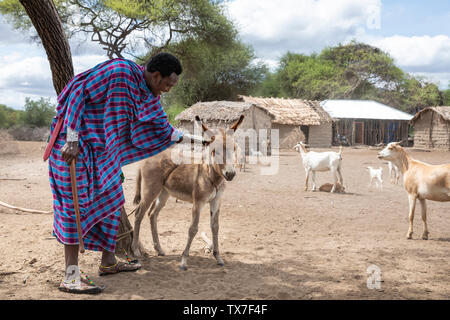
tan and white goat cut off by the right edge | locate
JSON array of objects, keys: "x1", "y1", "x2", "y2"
[{"x1": 378, "y1": 142, "x2": 450, "y2": 240}]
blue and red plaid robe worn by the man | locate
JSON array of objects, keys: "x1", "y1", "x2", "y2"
[{"x1": 49, "y1": 59, "x2": 183, "y2": 252}]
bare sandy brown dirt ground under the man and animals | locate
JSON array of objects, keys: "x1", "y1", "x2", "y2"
[{"x1": 0, "y1": 142, "x2": 450, "y2": 300}]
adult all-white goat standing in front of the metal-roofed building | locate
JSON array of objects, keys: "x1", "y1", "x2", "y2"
[{"x1": 294, "y1": 142, "x2": 344, "y2": 193}]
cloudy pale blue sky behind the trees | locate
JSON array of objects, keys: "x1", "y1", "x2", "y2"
[{"x1": 0, "y1": 0, "x2": 450, "y2": 109}]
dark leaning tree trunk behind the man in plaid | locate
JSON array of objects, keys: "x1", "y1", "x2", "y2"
[{"x1": 19, "y1": 0, "x2": 133, "y2": 254}]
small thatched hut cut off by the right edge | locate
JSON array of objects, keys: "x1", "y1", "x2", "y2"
[{"x1": 410, "y1": 106, "x2": 450, "y2": 150}]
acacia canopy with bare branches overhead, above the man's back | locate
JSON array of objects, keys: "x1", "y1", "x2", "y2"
[{"x1": 0, "y1": 0, "x2": 232, "y2": 59}]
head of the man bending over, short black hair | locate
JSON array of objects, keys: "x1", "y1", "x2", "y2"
[{"x1": 145, "y1": 52, "x2": 183, "y2": 97}]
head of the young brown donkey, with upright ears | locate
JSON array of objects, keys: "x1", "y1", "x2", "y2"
[{"x1": 195, "y1": 115, "x2": 244, "y2": 181}]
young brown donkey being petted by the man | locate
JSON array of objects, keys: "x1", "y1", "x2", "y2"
[{"x1": 132, "y1": 116, "x2": 244, "y2": 270}]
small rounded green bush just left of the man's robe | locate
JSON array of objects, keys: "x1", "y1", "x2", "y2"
[{"x1": 23, "y1": 98, "x2": 55, "y2": 127}]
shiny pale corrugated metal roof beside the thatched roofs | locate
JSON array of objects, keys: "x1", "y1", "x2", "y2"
[{"x1": 320, "y1": 100, "x2": 413, "y2": 120}]
